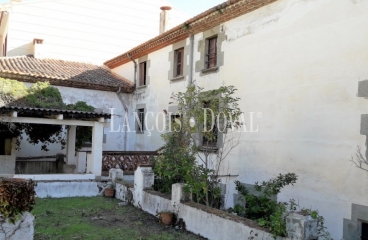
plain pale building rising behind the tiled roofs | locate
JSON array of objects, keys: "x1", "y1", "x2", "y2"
[{"x1": 0, "y1": 0, "x2": 189, "y2": 65}]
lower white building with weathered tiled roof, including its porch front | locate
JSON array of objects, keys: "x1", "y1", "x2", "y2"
[{"x1": 0, "y1": 56, "x2": 134, "y2": 174}]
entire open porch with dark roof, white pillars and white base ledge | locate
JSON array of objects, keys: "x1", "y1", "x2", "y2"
[{"x1": 0, "y1": 107, "x2": 110, "y2": 181}]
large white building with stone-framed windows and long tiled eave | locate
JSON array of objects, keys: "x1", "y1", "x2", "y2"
[{"x1": 105, "y1": 0, "x2": 368, "y2": 239}]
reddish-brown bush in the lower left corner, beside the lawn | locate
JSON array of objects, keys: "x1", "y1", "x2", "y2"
[{"x1": 0, "y1": 178, "x2": 35, "y2": 223}]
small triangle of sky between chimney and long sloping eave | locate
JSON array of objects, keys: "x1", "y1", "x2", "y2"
[{"x1": 168, "y1": 0, "x2": 225, "y2": 16}]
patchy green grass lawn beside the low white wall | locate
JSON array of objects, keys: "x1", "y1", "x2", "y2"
[{"x1": 32, "y1": 197, "x2": 202, "y2": 240}]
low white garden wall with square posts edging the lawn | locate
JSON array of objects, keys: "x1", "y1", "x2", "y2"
[{"x1": 112, "y1": 166, "x2": 317, "y2": 240}]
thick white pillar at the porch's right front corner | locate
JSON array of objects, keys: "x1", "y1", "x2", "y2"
[{"x1": 87, "y1": 122, "x2": 104, "y2": 177}]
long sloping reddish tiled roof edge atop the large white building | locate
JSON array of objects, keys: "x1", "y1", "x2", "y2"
[{"x1": 104, "y1": 0, "x2": 277, "y2": 68}]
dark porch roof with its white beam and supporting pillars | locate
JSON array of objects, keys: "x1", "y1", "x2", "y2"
[{"x1": 0, "y1": 107, "x2": 111, "y2": 178}]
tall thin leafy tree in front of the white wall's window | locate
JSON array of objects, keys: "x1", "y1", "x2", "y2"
[{"x1": 156, "y1": 84, "x2": 241, "y2": 207}]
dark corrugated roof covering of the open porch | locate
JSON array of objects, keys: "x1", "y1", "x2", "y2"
[{"x1": 0, "y1": 107, "x2": 111, "y2": 119}]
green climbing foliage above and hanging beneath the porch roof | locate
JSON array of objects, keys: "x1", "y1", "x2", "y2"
[{"x1": 0, "y1": 78, "x2": 94, "y2": 151}]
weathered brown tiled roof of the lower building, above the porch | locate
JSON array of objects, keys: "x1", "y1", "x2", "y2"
[{"x1": 0, "y1": 55, "x2": 134, "y2": 93}]
